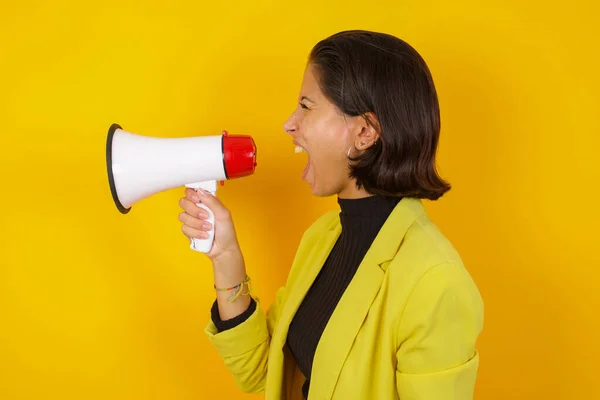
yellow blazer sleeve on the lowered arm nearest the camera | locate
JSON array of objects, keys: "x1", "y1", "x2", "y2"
[{"x1": 396, "y1": 262, "x2": 483, "y2": 400}]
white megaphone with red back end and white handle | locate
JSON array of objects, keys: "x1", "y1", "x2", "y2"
[{"x1": 106, "y1": 124, "x2": 256, "y2": 253}]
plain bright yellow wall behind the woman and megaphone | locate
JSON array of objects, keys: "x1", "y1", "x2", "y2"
[{"x1": 0, "y1": 0, "x2": 600, "y2": 400}]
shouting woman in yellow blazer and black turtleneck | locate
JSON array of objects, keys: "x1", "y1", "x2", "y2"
[{"x1": 180, "y1": 31, "x2": 483, "y2": 400}]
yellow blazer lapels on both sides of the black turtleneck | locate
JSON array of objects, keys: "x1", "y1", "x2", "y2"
[{"x1": 310, "y1": 198, "x2": 424, "y2": 399}]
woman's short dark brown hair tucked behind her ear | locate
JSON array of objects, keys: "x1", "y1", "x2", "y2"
[{"x1": 309, "y1": 30, "x2": 450, "y2": 200}]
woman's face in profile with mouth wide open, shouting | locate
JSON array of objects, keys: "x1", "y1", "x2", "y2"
[{"x1": 284, "y1": 64, "x2": 364, "y2": 197}]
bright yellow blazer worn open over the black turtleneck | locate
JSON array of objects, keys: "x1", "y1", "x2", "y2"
[{"x1": 205, "y1": 198, "x2": 483, "y2": 400}]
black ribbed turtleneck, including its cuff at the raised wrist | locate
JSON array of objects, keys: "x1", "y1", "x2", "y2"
[{"x1": 212, "y1": 196, "x2": 400, "y2": 398}]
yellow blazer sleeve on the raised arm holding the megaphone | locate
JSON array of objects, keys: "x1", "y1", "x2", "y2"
[{"x1": 204, "y1": 287, "x2": 285, "y2": 394}]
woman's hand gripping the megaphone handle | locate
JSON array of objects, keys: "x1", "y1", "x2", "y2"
[{"x1": 179, "y1": 188, "x2": 240, "y2": 262}]
